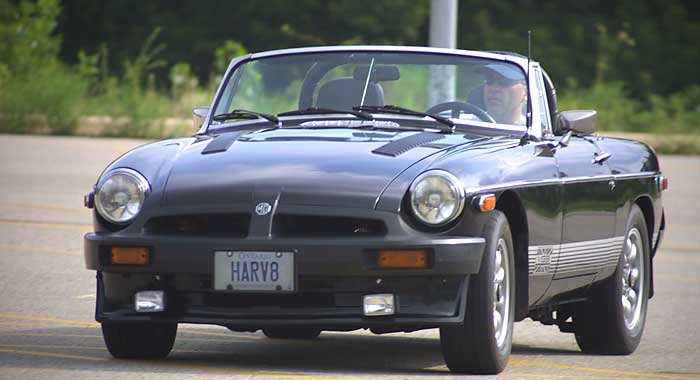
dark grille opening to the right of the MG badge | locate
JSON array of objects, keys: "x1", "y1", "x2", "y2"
[{"x1": 272, "y1": 214, "x2": 386, "y2": 238}]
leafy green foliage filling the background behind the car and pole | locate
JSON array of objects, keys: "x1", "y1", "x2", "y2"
[{"x1": 0, "y1": 0, "x2": 700, "y2": 141}]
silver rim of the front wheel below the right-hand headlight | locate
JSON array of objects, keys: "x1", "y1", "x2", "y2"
[{"x1": 493, "y1": 239, "x2": 511, "y2": 347}]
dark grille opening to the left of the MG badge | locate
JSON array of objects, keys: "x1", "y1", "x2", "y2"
[{"x1": 144, "y1": 213, "x2": 250, "y2": 238}]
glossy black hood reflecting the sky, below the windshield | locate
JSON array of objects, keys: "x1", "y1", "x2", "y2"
[{"x1": 162, "y1": 129, "x2": 492, "y2": 208}]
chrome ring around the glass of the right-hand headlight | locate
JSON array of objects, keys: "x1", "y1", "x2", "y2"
[{"x1": 408, "y1": 169, "x2": 466, "y2": 227}]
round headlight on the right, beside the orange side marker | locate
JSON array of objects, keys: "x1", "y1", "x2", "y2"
[{"x1": 409, "y1": 170, "x2": 465, "y2": 227}]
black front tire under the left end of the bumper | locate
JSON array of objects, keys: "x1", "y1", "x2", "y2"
[{"x1": 102, "y1": 322, "x2": 177, "y2": 359}]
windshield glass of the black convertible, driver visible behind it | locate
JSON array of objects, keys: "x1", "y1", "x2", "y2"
[{"x1": 212, "y1": 52, "x2": 527, "y2": 126}]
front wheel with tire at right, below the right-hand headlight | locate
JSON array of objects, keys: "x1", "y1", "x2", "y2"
[{"x1": 440, "y1": 210, "x2": 515, "y2": 374}]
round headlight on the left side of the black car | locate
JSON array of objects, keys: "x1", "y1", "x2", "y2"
[{"x1": 95, "y1": 168, "x2": 151, "y2": 224}]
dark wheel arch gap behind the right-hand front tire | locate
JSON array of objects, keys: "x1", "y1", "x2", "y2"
[{"x1": 496, "y1": 190, "x2": 529, "y2": 321}]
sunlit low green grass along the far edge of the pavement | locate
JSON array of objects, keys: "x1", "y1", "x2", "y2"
[{"x1": 0, "y1": 63, "x2": 700, "y2": 155}]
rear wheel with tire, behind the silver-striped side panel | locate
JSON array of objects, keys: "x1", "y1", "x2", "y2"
[{"x1": 573, "y1": 205, "x2": 651, "y2": 355}]
